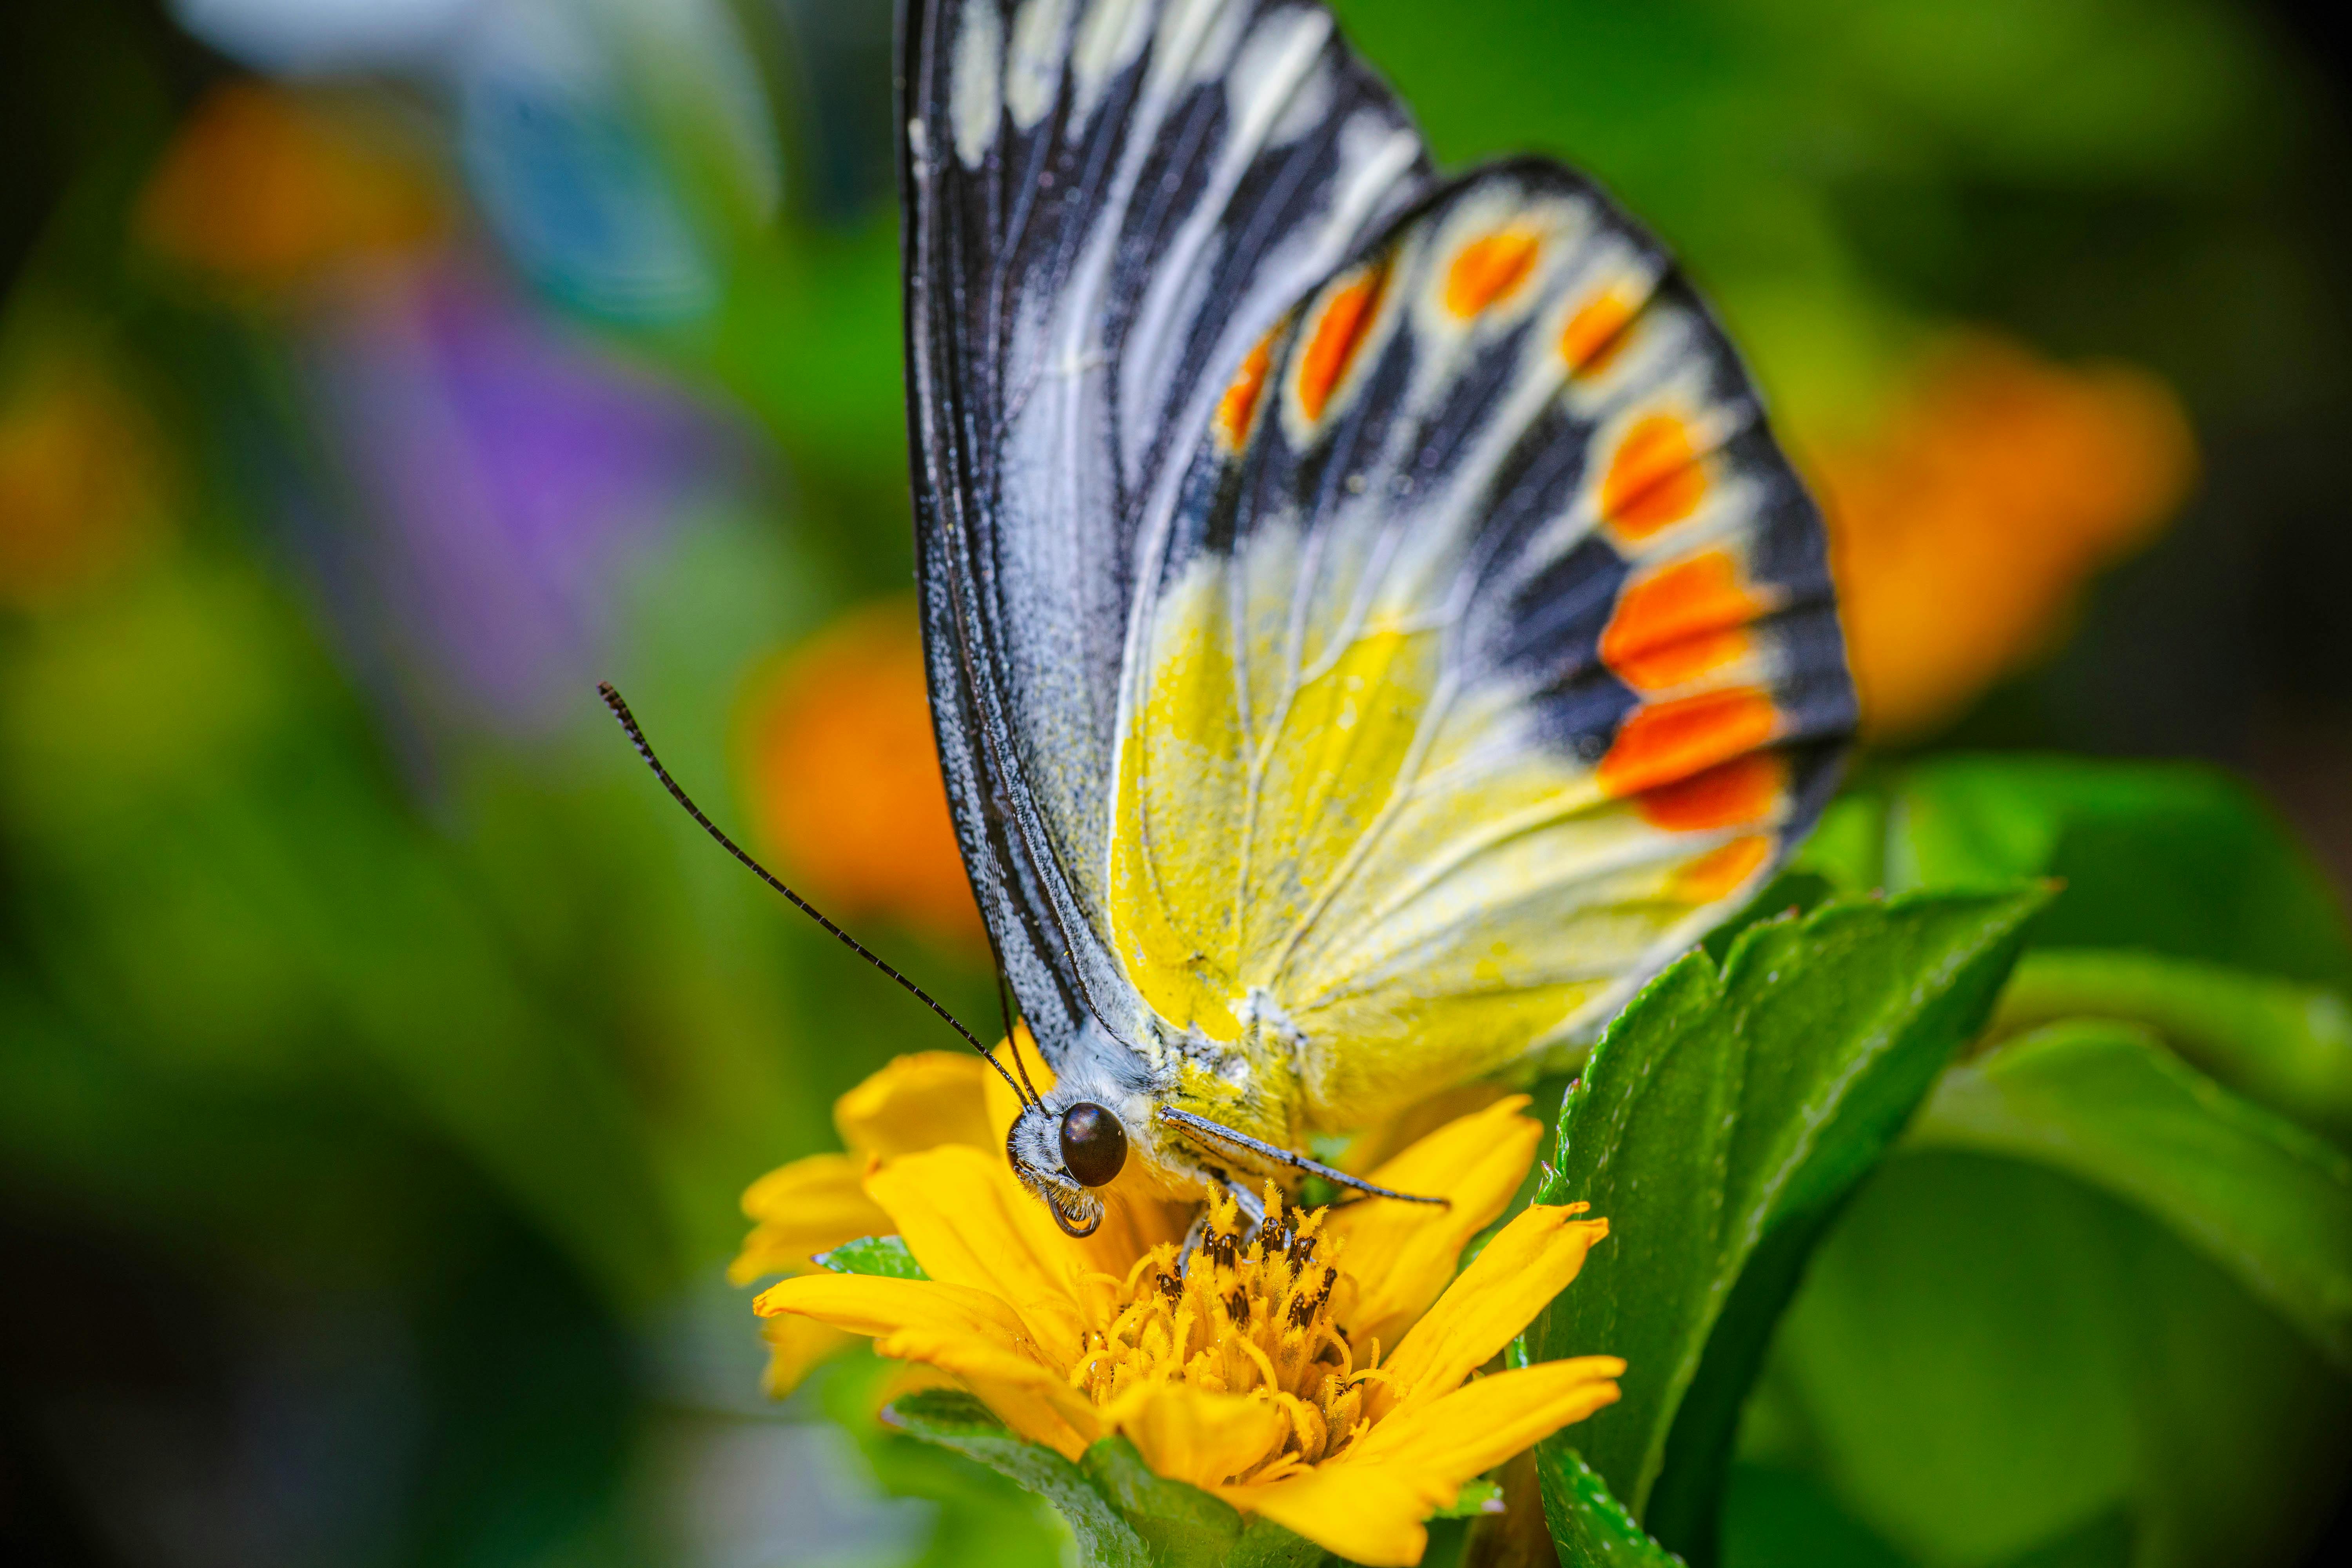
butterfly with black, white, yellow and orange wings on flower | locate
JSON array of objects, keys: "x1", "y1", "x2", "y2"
[{"x1": 901, "y1": 0, "x2": 1856, "y2": 1234}]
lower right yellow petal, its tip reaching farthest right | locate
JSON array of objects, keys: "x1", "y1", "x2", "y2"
[{"x1": 1336, "y1": 1356, "x2": 1625, "y2": 1500}]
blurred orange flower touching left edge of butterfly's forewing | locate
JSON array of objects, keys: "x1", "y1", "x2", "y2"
[{"x1": 750, "y1": 599, "x2": 985, "y2": 947}]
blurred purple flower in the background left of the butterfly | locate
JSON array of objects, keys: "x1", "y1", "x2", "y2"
[{"x1": 303, "y1": 261, "x2": 746, "y2": 733}]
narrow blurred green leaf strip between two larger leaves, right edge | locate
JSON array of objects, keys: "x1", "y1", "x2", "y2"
[{"x1": 1992, "y1": 950, "x2": 2352, "y2": 1143}]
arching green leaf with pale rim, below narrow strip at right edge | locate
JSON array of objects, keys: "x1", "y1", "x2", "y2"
[{"x1": 1912, "y1": 1018, "x2": 2352, "y2": 1370}]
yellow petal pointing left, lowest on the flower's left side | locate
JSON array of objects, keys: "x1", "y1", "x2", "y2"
[{"x1": 753, "y1": 1274, "x2": 1103, "y2": 1460}]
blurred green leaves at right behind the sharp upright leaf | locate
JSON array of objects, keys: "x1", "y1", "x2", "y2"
[{"x1": 1759, "y1": 757, "x2": 2352, "y2": 1563}]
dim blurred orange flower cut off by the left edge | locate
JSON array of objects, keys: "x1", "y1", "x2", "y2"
[{"x1": 0, "y1": 350, "x2": 167, "y2": 609}]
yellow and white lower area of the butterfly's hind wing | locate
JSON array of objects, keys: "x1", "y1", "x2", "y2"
[{"x1": 1110, "y1": 538, "x2": 1783, "y2": 1138}]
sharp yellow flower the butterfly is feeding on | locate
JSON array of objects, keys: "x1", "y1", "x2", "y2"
[{"x1": 757, "y1": 1096, "x2": 1625, "y2": 1566}]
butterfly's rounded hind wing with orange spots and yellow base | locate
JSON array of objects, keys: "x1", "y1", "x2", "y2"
[{"x1": 1110, "y1": 160, "x2": 1856, "y2": 1126}]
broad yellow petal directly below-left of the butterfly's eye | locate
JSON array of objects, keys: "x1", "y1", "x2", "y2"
[{"x1": 866, "y1": 1145, "x2": 1091, "y2": 1366}]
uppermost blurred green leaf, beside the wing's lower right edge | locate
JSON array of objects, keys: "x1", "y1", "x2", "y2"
[{"x1": 1835, "y1": 757, "x2": 2352, "y2": 990}]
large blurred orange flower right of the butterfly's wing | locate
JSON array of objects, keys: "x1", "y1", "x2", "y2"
[{"x1": 1813, "y1": 336, "x2": 2197, "y2": 740}]
